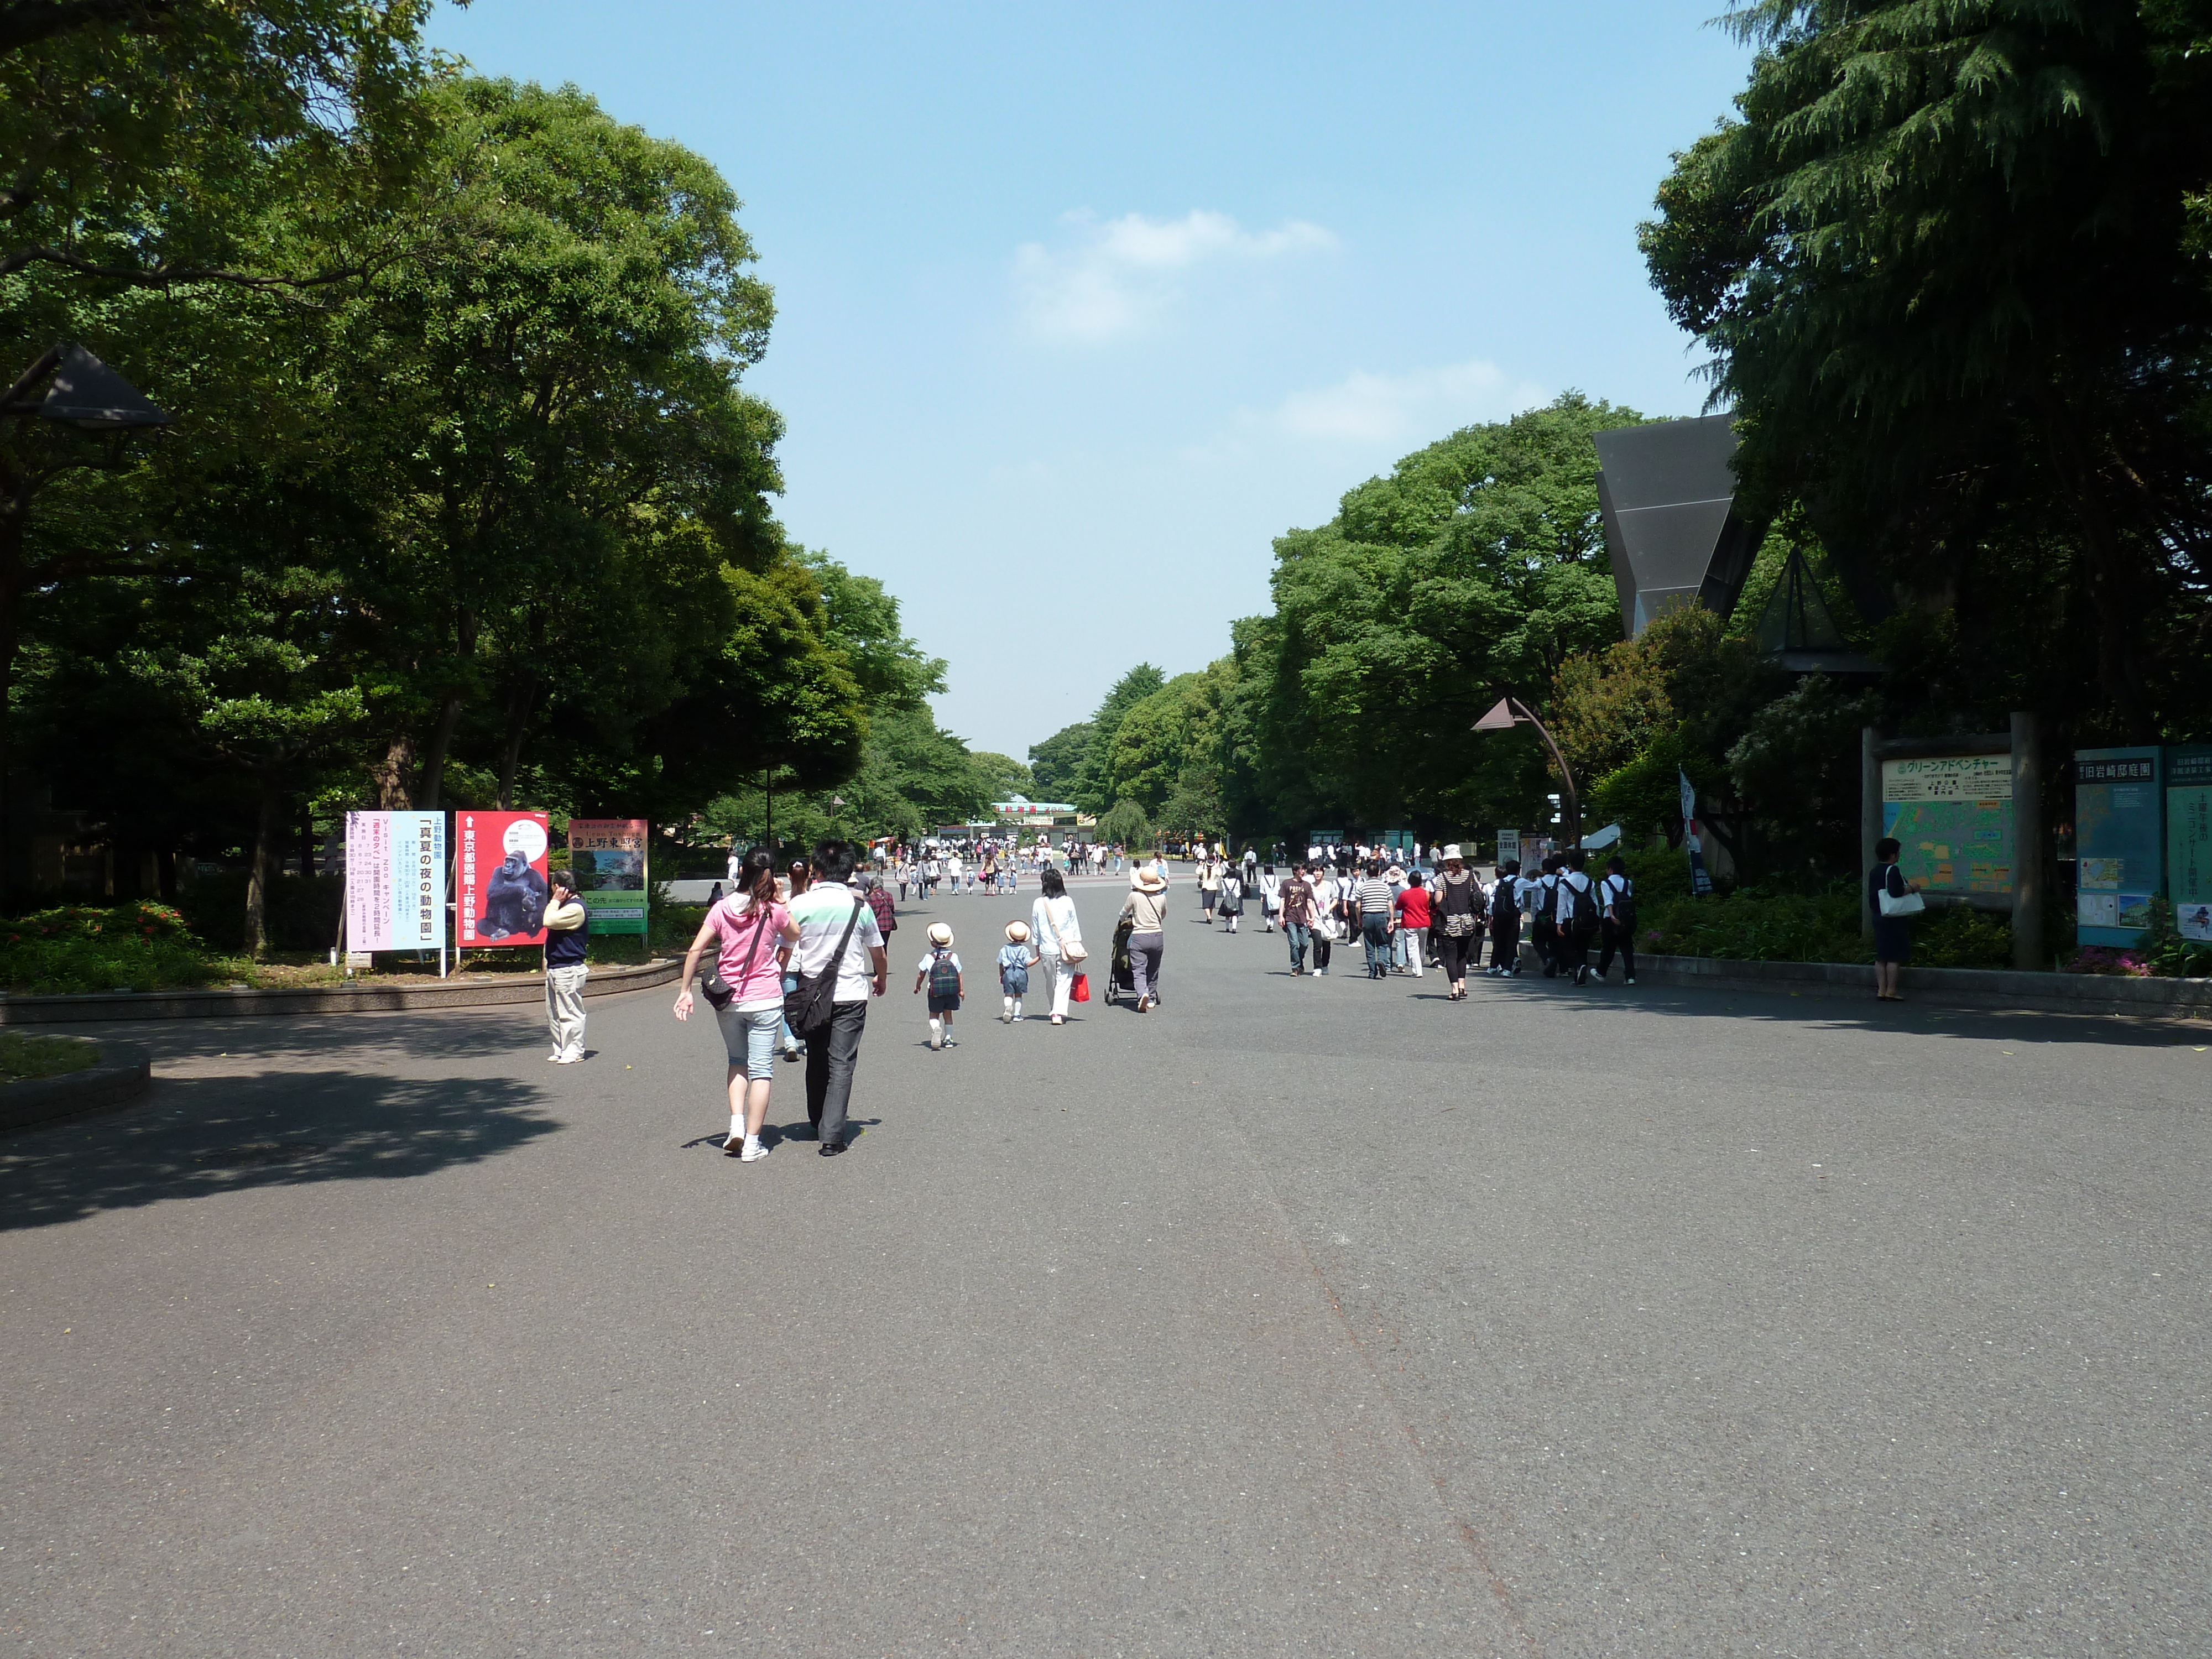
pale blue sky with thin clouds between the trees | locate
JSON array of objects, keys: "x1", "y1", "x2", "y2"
[{"x1": 434, "y1": 0, "x2": 1747, "y2": 754}]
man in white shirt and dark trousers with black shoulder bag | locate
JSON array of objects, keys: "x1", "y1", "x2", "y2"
[{"x1": 790, "y1": 841, "x2": 891, "y2": 1157}]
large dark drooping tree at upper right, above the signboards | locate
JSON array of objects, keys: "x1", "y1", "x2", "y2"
[{"x1": 1644, "y1": 0, "x2": 2212, "y2": 737}]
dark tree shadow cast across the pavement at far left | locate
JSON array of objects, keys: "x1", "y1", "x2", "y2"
[{"x1": 0, "y1": 1071, "x2": 560, "y2": 1230}]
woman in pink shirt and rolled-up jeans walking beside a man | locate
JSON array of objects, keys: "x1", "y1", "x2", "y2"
[{"x1": 675, "y1": 849, "x2": 799, "y2": 1164}]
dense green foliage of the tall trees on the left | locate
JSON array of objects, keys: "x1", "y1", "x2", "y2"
[{"x1": 0, "y1": 13, "x2": 978, "y2": 951}]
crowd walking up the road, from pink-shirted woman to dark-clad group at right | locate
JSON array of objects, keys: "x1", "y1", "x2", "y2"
[{"x1": 664, "y1": 841, "x2": 1635, "y2": 1164}]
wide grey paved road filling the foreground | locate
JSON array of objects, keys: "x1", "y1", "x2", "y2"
[{"x1": 0, "y1": 889, "x2": 2212, "y2": 1659}]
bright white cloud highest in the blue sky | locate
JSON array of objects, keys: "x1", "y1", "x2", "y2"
[{"x1": 1013, "y1": 208, "x2": 1336, "y2": 341}]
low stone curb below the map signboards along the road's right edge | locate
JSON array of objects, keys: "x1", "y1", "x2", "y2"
[{"x1": 1637, "y1": 951, "x2": 2212, "y2": 1020}]
